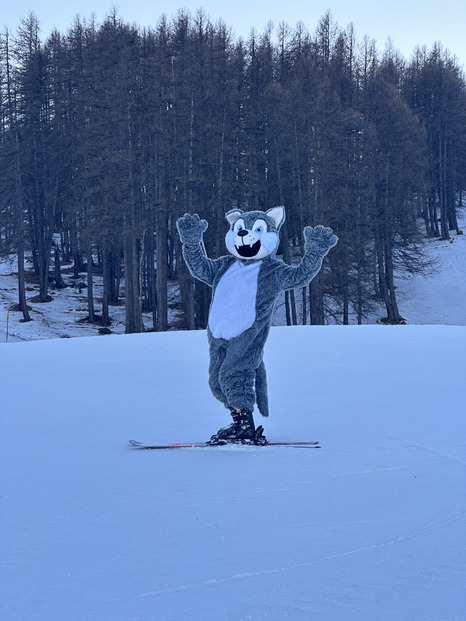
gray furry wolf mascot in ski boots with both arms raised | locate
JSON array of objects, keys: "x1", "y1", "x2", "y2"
[{"x1": 176, "y1": 207, "x2": 338, "y2": 444}]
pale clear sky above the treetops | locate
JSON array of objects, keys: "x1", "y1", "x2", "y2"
[{"x1": 0, "y1": 0, "x2": 466, "y2": 67}]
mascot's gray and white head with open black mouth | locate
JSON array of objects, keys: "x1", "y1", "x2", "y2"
[{"x1": 225, "y1": 207, "x2": 285, "y2": 260}]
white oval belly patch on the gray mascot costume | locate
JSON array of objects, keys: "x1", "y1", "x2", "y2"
[{"x1": 209, "y1": 261, "x2": 262, "y2": 341}]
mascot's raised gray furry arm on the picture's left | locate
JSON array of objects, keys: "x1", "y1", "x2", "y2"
[{"x1": 176, "y1": 213, "x2": 218, "y2": 286}]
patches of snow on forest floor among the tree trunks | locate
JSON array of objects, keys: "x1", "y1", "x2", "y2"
[{"x1": 0, "y1": 213, "x2": 466, "y2": 342}]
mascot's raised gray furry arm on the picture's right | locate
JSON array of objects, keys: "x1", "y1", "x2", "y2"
[{"x1": 277, "y1": 225, "x2": 338, "y2": 290}]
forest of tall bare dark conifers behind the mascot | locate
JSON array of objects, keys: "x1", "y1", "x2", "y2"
[{"x1": 0, "y1": 10, "x2": 466, "y2": 333}]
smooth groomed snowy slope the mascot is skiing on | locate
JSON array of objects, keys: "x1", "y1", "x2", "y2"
[{"x1": 0, "y1": 326, "x2": 466, "y2": 621}]
